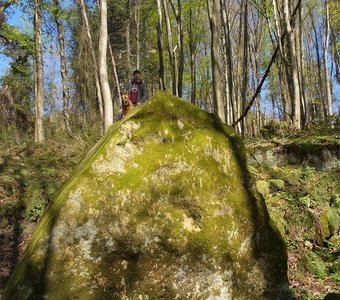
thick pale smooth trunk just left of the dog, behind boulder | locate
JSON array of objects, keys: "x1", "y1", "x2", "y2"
[{"x1": 98, "y1": 0, "x2": 113, "y2": 132}]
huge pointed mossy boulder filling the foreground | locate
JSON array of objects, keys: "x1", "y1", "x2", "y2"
[{"x1": 4, "y1": 92, "x2": 288, "y2": 300}]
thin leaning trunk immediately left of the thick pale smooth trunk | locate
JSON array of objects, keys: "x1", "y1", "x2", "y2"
[{"x1": 77, "y1": 0, "x2": 104, "y2": 117}]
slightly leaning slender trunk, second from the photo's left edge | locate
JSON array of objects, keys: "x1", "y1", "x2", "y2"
[{"x1": 53, "y1": 0, "x2": 74, "y2": 136}]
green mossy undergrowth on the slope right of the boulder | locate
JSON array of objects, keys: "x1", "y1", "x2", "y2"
[{"x1": 250, "y1": 136, "x2": 340, "y2": 300}]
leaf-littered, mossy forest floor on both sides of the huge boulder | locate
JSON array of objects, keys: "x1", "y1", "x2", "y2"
[{"x1": 0, "y1": 131, "x2": 340, "y2": 300}]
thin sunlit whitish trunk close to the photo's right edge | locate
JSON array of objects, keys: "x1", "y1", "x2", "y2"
[{"x1": 323, "y1": 0, "x2": 333, "y2": 117}]
